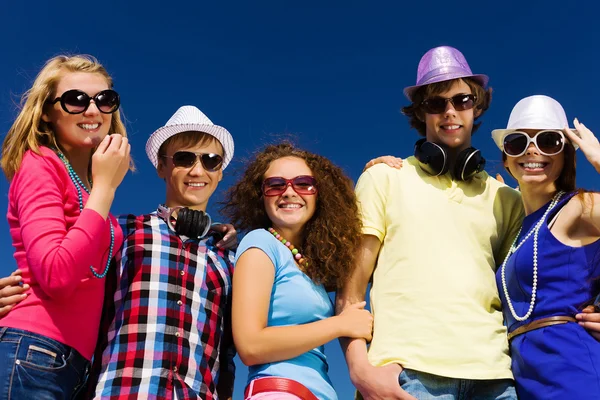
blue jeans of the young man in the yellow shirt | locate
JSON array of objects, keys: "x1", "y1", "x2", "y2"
[{"x1": 398, "y1": 369, "x2": 517, "y2": 400}]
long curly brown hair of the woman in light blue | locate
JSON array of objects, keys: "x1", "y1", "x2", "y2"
[{"x1": 221, "y1": 141, "x2": 362, "y2": 290}]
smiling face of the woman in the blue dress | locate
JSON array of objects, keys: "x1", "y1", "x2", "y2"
[{"x1": 504, "y1": 129, "x2": 565, "y2": 190}]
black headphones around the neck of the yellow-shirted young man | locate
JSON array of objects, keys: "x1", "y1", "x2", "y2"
[{"x1": 415, "y1": 139, "x2": 485, "y2": 181}]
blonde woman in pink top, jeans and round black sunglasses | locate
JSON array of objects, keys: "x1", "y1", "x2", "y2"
[{"x1": 0, "y1": 56, "x2": 130, "y2": 399}]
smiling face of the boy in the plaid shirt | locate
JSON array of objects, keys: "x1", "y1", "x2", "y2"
[{"x1": 156, "y1": 140, "x2": 223, "y2": 211}]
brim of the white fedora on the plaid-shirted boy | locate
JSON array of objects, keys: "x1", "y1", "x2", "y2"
[{"x1": 146, "y1": 124, "x2": 234, "y2": 169}]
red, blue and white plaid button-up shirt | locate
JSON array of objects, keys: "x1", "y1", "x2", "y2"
[{"x1": 91, "y1": 212, "x2": 235, "y2": 400}]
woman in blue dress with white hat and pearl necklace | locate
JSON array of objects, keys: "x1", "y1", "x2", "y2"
[{"x1": 492, "y1": 96, "x2": 600, "y2": 400}]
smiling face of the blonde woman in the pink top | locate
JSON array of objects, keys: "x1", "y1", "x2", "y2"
[{"x1": 42, "y1": 72, "x2": 112, "y2": 152}]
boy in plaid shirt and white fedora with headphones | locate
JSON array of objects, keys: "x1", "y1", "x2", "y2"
[{"x1": 92, "y1": 106, "x2": 235, "y2": 400}]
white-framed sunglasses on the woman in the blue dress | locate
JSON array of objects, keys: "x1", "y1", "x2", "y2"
[{"x1": 502, "y1": 130, "x2": 565, "y2": 157}]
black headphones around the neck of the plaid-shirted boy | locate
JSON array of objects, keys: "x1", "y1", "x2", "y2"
[{"x1": 158, "y1": 204, "x2": 212, "y2": 239}]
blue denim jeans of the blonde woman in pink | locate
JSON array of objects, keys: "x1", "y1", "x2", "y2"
[{"x1": 0, "y1": 327, "x2": 89, "y2": 400}]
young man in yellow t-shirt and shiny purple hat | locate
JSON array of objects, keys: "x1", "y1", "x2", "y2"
[{"x1": 337, "y1": 46, "x2": 523, "y2": 400}]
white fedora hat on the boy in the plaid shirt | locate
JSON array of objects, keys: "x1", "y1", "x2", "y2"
[{"x1": 146, "y1": 106, "x2": 234, "y2": 169}]
